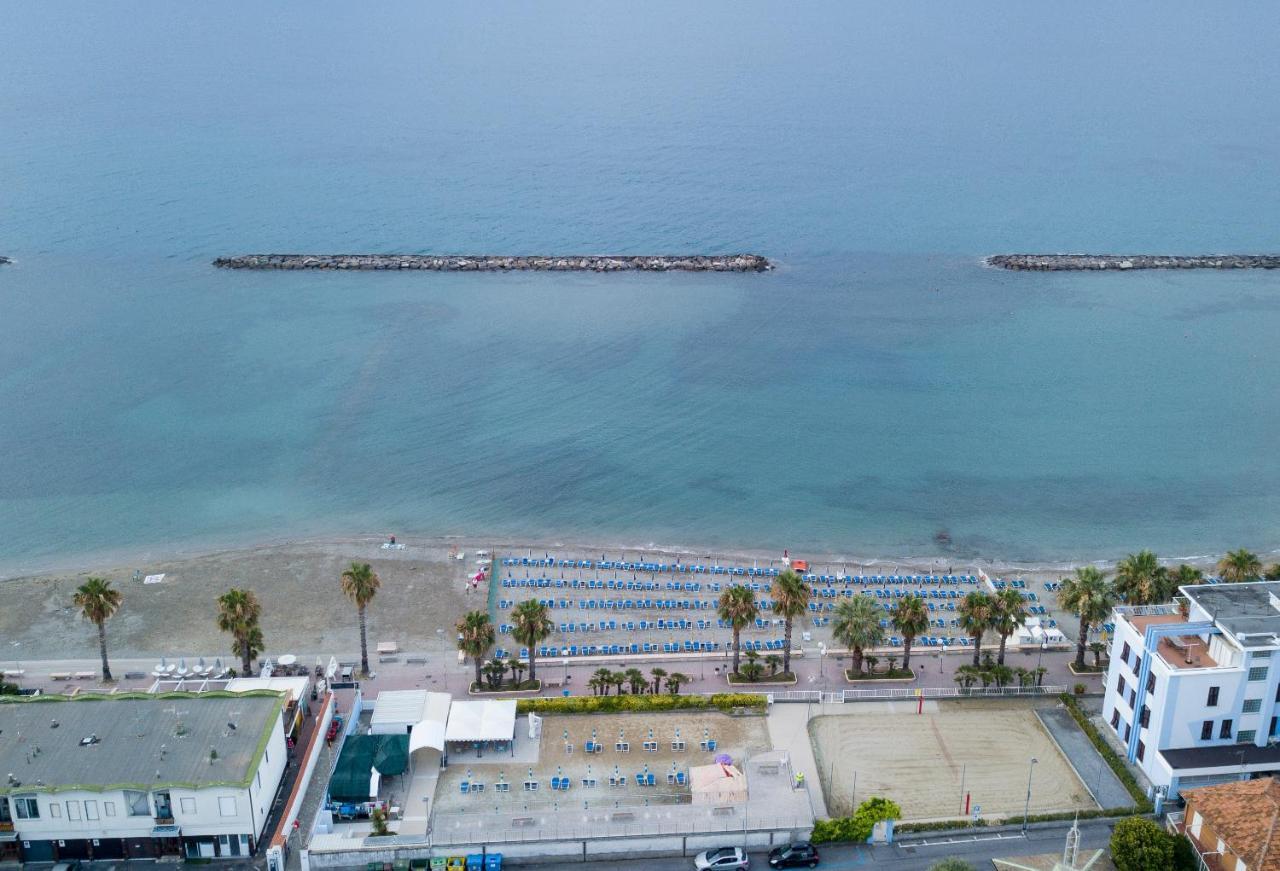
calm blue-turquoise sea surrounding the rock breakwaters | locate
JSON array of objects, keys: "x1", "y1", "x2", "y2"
[{"x1": 0, "y1": 0, "x2": 1280, "y2": 571}]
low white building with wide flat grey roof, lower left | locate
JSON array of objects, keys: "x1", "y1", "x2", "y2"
[{"x1": 0, "y1": 692, "x2": 287, "y2": 862}]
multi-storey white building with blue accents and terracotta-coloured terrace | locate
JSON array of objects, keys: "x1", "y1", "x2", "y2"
[{"x1": 1102, "y1": 582, "x2": 1280, "y2": 798}]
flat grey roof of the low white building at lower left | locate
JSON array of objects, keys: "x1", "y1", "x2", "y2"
[{"x1": 0, "y1": 690, "x2": 284, "y2": 794}]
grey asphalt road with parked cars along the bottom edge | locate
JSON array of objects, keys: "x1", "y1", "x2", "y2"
[{"x1": 576, "y1": 820, "x2": 1111, "y2": 871}]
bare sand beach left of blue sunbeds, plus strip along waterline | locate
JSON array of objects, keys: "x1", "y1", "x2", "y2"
[{"x1": 0, "y1": 535, "x2": 1223, "y2": 661}]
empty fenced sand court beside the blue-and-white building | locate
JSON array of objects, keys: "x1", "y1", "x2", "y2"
[{"x1": 809, "y1": 701, "x2": 1097, "y2": 820}]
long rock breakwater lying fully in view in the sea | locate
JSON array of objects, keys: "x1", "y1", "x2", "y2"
[{"x1": 214, "y1": 254, "x2": 772, "y2": 272}]
